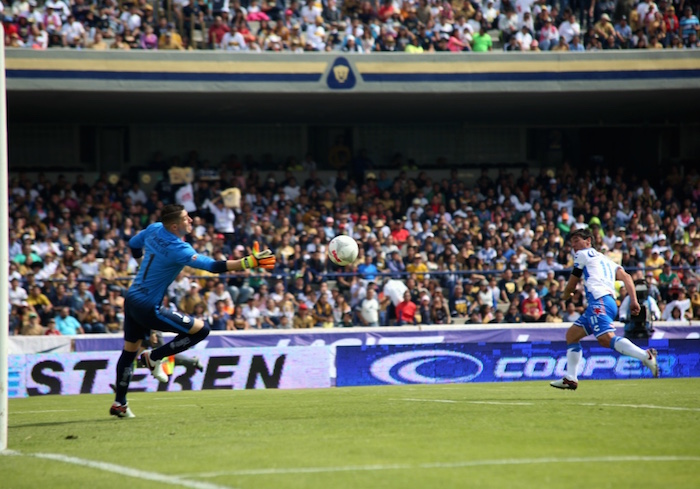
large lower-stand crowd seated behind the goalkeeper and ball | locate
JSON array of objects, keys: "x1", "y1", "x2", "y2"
[{"x1": 9, "y1": 150, "x2": 700, "y2": 334}]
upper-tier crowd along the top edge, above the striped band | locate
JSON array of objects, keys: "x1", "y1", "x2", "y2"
[{"x1": 0, "y1": 0, "x2": 700, "y2": 53}]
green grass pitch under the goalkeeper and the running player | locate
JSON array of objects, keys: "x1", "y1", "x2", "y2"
[{"x1": 0, "y1": 379, "x2": 700, "y2": 489}]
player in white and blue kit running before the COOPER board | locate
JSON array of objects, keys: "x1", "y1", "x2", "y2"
[{"x1": 550, "y1": 229, "x2": 659, "y2": 390}]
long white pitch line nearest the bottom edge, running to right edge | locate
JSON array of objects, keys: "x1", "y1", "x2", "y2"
[{"x1": 188, "y1": 455, "x2": 700, "y2": 478}]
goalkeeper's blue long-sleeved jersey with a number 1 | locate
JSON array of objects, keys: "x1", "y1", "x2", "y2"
[{"x1": 127, "y1": 222, "x2": 216, "y2": 305}]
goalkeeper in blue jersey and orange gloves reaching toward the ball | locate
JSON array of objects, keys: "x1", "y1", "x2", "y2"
[{"x1": 109, "y1": 204, "x2": 275, "y2": 418}]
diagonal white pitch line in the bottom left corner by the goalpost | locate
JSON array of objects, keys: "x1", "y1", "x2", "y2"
[{"x1": 0, "y1": 450, "x2": 237, "y2": 489}]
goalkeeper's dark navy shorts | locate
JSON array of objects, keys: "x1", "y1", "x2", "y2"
[{"x1": 124, "y1": 297, "x2": 194, "y2": 342}]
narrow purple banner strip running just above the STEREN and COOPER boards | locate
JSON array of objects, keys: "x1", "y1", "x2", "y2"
[{"x1": 75, "y1": 324, "x2": 700, "y2": 351}]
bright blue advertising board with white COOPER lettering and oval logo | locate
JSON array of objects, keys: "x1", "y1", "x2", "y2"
[{"x1": 336, "y1": 340, "x2": 700, "y2": 387}]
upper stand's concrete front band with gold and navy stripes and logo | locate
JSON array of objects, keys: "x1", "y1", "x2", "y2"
[{"x1": 7, "y1": 50, "x2": 700, "y2": 93}]
